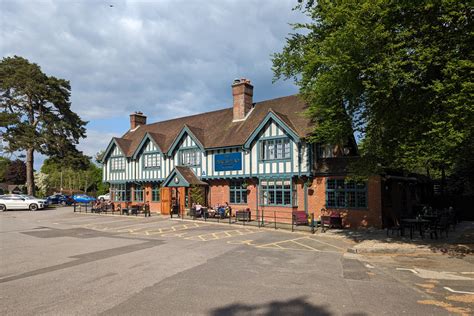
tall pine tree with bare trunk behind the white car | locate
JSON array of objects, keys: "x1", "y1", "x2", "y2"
[{"x1": 0, "y1": 56, "x2": 86, "y2": 195}]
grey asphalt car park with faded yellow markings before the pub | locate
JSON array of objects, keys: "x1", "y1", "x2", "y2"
[{"x1": 0, "y1": 207, "x2": 471, "y2": 315}]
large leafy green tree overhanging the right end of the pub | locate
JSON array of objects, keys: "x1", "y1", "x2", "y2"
[{"x1": 273, "y1": 0, "x2": 474, "y2": 178}]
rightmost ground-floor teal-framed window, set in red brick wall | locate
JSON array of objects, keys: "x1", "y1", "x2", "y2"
[{"x1": 326, "y1": 179, "x2": 367, "y2": 208}]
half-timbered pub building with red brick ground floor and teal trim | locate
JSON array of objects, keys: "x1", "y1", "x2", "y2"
[{"x1": 102, "y1": 79, "x2": 382, "y2": 227}]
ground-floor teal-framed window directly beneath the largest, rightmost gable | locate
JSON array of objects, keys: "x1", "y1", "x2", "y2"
[{"x1": 260, "y1": 180, "x2": 296, "y2": 206}]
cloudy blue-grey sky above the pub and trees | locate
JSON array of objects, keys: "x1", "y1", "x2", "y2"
[{"x1": 0, "y1": 0, "x2": 305, "y2": 169}]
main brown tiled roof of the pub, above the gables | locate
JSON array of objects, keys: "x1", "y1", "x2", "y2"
[{"x1": 116, "y1": 95, "x2": 312, "y2": 157}]
